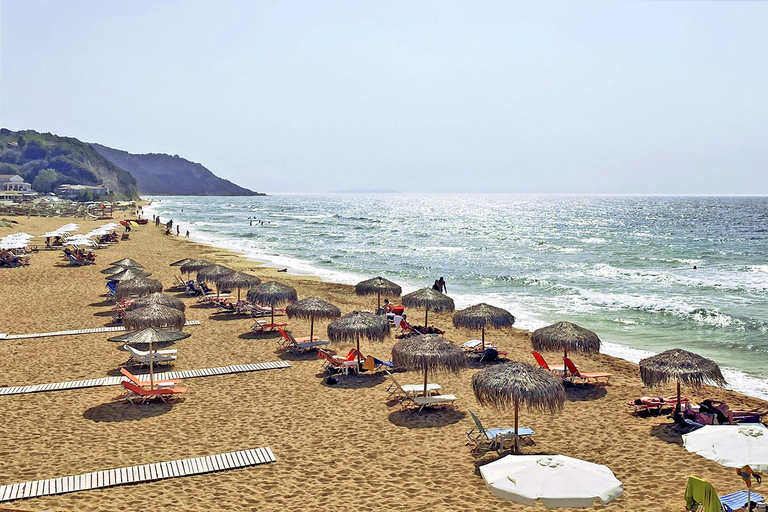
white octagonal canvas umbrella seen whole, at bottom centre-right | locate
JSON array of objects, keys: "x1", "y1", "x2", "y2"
[{"x1": 480, "y1": 455, "x2": 624, "y2": 510}]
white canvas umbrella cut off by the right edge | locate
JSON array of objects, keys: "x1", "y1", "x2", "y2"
[{"x1": 683, "y1": 423, "x2": 768, "y2": 503}]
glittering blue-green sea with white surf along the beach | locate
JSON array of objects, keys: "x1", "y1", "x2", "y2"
[{"x1": 145, "y1": 193, "x2": 768, "y2": 399}]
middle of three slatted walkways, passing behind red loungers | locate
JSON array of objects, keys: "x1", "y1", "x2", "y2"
[{"x1": 0, "y1": 361, "x2": 291, "y2": 395}]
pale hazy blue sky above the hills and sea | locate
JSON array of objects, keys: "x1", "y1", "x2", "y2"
[{"x1": 0, "y1": 0, "x2": 768, "y2": 194}]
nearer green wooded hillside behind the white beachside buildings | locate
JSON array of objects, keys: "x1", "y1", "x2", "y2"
[{"x1": 0, "y1": 128, "x2": 139, "y2": 200}]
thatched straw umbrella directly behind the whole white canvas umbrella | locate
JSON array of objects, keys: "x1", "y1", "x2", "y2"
[{"x1": 472, "y1": 361, "x2": 565, "y2": 452}]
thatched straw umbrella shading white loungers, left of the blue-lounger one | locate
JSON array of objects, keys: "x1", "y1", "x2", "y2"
[{"x1": 392, "y1": 334, "x2": 467, "y2": 396}]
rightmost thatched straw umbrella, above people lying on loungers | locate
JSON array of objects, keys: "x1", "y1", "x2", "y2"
[{"x1": 640, "y1": 348, "x2": 727, "y2": 418}]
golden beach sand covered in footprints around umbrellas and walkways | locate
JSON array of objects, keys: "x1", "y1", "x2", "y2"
[{"x1": 0, "y1": 213, "x2": 766, "y2": 512}]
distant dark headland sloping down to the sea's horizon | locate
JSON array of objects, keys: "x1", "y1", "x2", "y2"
[{"x1": 91, "y1": 144, "x2": 264, "y2": 196}]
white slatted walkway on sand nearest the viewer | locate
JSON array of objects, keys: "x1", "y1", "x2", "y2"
[{"x1": 0, "y1": 446, "x2": 276, "y2": 502}]
